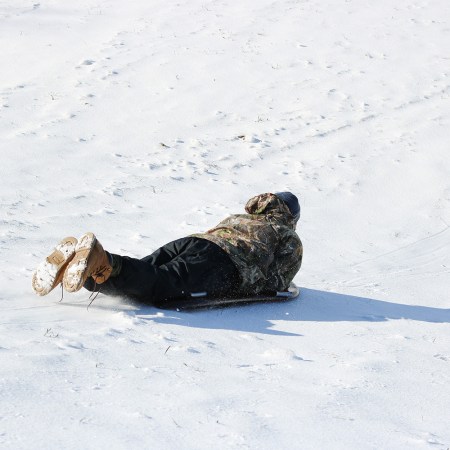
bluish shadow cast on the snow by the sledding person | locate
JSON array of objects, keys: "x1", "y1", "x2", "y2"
[{"x1": 129, "y1": 288, "x2": 450, "y2": 336}]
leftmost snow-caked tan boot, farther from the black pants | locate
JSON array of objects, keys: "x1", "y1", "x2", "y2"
[{"x1": 31, "y1": 237, "x2": 78, "y2": 295}]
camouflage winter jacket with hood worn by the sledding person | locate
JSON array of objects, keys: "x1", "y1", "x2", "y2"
[{"x1": 195, "y1": 193, "x2": 303, "y2": 293}]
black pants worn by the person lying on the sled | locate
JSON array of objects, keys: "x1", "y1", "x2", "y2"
[{"x1": 84, "y1": 237, "x2": 240, "y2": 304}]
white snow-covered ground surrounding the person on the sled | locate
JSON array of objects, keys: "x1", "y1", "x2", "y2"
[{"x1": 0, "y1": 0, "x2": 450, "y2": 450}]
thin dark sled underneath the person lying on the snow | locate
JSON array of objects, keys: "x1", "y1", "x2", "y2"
[{"x1": 155, "y1": 283, "x2": 300, "y2": 310}]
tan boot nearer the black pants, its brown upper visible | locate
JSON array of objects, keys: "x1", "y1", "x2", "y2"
[{"x1": 63, "y1": 233, "x2": 112, "y2": 292}]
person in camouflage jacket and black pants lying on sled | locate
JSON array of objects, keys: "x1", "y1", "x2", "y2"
[{"x1": 32, "y1": 192, "x2": 303, "y2": 304}]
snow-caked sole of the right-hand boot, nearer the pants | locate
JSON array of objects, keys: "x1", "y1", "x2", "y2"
[{"x1": 63, "y1": 232, "x2": 97, "y2": 292}]
